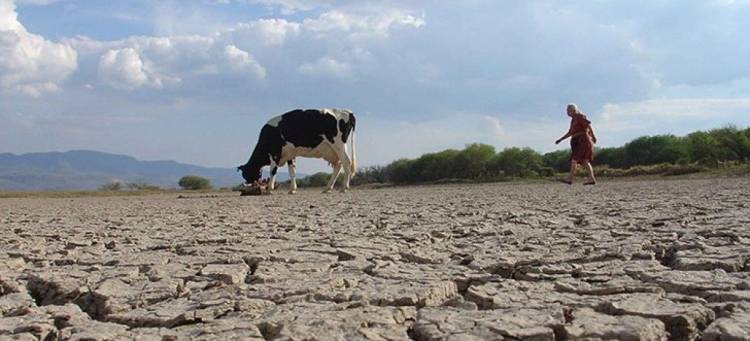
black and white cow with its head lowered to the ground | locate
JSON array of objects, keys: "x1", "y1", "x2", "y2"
[{"x1": 237, "y1": 109, "x2": 357, "y2": 194}]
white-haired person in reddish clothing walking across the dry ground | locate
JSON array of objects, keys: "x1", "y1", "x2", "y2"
[{"x1": 555, "y1": 103, "x2": 596, "y2": 185}]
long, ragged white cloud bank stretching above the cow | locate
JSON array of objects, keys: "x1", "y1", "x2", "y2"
[{"x1": 69, "y1": 4, "x2": 424, "y2": 90}]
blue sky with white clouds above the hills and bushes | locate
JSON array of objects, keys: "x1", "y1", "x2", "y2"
[{"x1": 0, "y1": 0, "x2": 750, "y2": 172}]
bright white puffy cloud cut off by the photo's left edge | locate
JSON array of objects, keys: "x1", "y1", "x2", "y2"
[{"x1": 0, "y1": 0, "x2": 78, "y2": 97}]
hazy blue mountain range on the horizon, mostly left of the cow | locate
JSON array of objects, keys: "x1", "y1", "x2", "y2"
[{"x1": 0, "y1": 150, "x2": 294, "y2": 191}]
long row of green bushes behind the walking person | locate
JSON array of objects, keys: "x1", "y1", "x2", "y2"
[{"x1": 352, "y1": 126, "x2": 750, "y2": 186}]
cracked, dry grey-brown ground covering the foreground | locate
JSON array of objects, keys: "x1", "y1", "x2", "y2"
[{"x1": 0, "y1": 178, "x2": 750, "y2": 340}]
